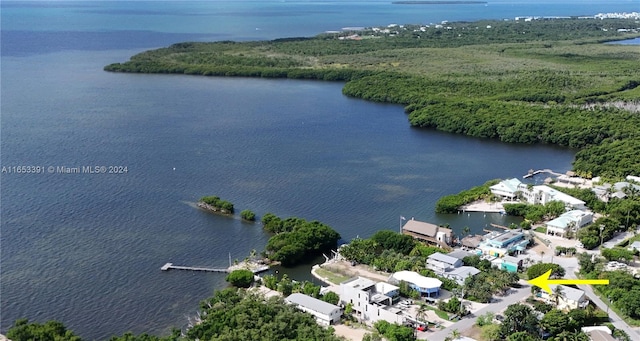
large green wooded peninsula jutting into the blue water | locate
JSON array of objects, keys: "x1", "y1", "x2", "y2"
[{"x1": 104, "y1": 18, "x2": 640, "y2": 177}]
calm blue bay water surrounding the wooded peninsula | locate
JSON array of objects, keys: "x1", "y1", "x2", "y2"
[{"x1": 0, "y1": 1, "x2": 638, "y2": 339}]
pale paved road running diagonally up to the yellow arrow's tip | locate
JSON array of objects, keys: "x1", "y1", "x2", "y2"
[{"x1": 418, "y1": 280, "x2": 531, "y2": 341}]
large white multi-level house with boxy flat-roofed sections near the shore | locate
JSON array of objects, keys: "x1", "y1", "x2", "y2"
[{"x1": 340, "y1": 277, "x2": 404, "y2": 324}]
